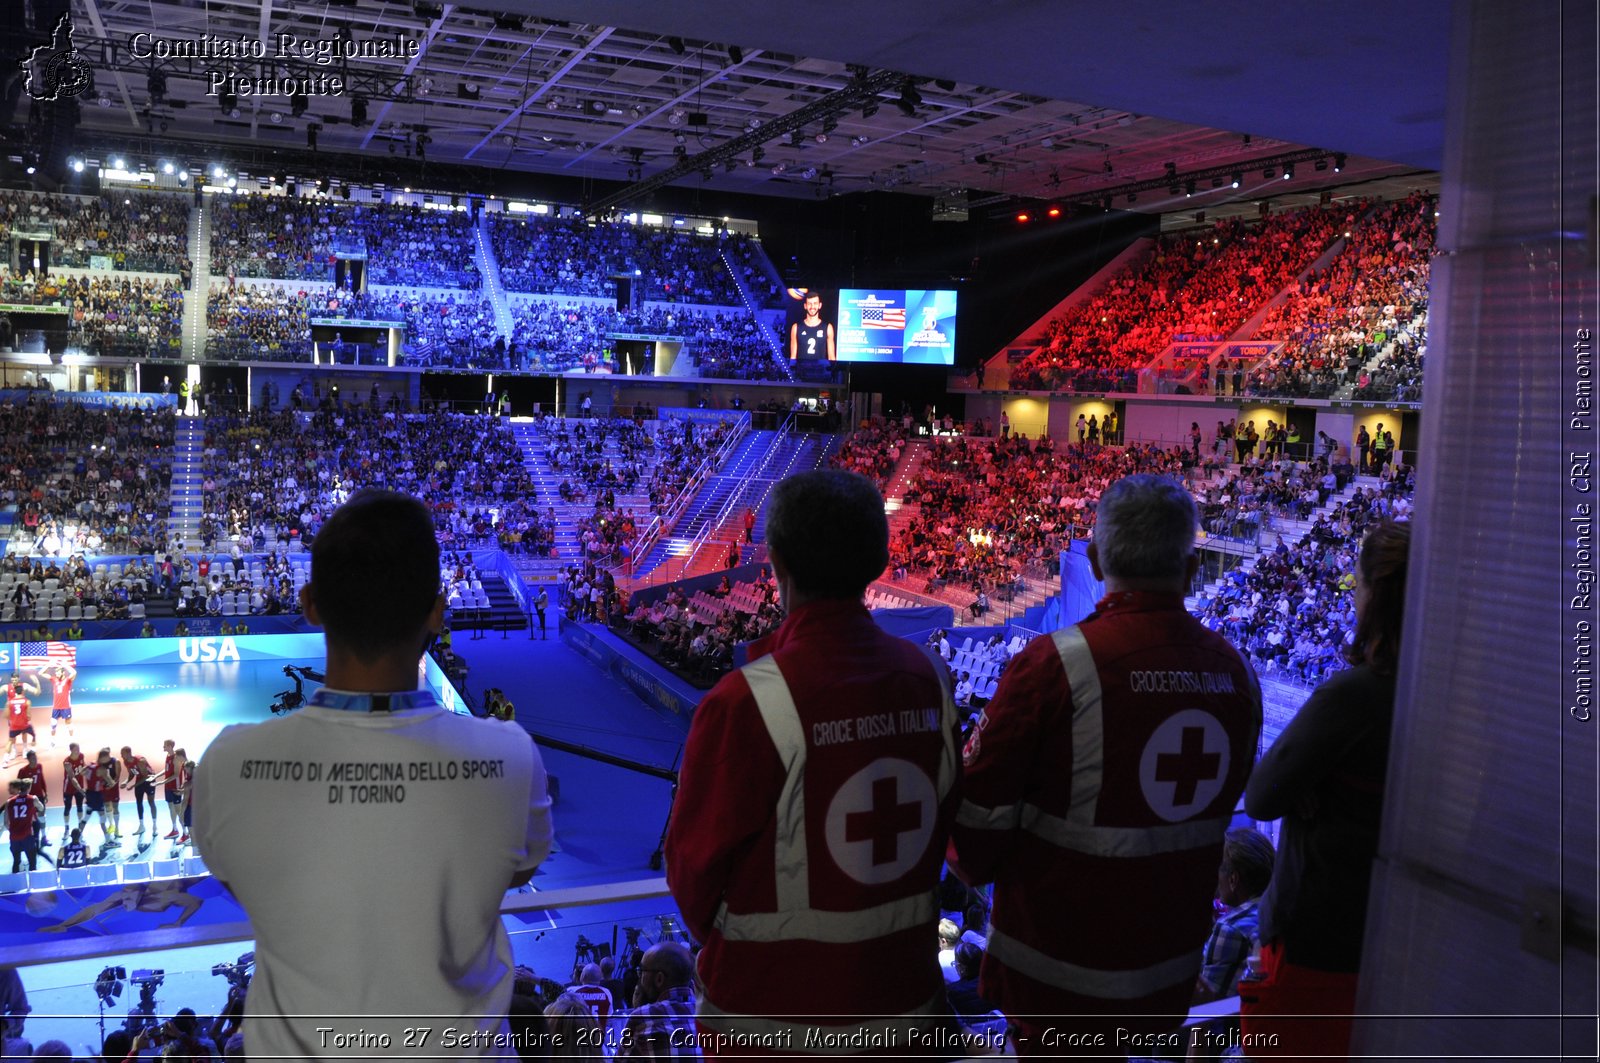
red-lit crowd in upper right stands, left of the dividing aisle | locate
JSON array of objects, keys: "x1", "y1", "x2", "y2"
[{"x1": 1010, "y1": 207, "x2": 1354, "y2": 391}]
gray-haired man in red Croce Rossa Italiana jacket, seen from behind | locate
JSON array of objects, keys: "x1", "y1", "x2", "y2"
[{"x1": 950, "y1": 475, "x2": 1261, "y2": 1055}]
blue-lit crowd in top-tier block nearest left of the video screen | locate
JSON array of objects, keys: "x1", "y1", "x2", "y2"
[{"x1": 491, "y1": 216, "x2": 739, "y2": 306}]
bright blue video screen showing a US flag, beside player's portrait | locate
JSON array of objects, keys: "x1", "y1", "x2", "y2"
[{"x1": 837, "y1": 288, "x2": 955, "y2": 365}]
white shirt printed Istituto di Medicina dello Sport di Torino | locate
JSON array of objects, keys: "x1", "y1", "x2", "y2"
[{"x1": 194, "y1": 706, "x2": 552, "y2": 1058}]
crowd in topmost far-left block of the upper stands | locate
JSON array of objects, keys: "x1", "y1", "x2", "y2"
[{"x1": 0, "y1": 189, "x2": 189, "y2": 275}]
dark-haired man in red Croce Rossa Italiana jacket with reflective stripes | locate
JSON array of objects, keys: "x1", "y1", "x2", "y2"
[{"x1": 666, "y1": 469, "x2": 958, "y2": 1050}]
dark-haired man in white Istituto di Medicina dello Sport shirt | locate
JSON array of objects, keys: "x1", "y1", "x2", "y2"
[{"x1": 194, "y1": 490, "x2": 550, "y2": 1058}]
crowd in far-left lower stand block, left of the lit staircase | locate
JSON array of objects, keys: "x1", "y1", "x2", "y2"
[{"x1": 0, "y1": 393, "x2": 176, "y2": 557}]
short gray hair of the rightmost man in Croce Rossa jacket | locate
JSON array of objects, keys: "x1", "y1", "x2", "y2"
[{"x1": 1090, "y1": 472, "x2": 1200, "y2": 589}]
